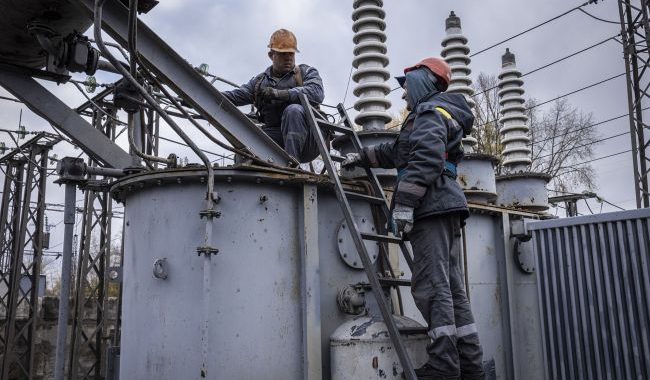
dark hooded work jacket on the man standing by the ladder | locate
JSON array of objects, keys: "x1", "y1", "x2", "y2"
[{"x1": 363, "y1": 93, "x2": 474, "y2": 219}]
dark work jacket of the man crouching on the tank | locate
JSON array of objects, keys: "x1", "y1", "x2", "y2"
[{"x1": 223, "y1": 64, "x2": 325, "y2": 128}]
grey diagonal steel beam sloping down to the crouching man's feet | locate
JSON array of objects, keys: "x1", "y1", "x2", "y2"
[{"x1": 78, "y1": 0, "x2": 295, "y2": 165}]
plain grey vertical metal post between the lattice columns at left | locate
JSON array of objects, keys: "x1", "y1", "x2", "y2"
[{"x1": 54, "y1": 182, "x2": 77, "y2": 380}]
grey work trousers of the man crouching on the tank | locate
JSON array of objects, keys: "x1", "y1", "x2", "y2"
[{"x1": 262, "y1": 104, "x2": 319, "y2": 163}]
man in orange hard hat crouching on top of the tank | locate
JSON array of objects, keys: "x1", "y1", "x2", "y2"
[{"x1": 223, "y1": 29, "x2": 325, "y2": 162}]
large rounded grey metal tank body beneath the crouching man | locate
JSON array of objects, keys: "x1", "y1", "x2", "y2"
[{"x1": 112, "y1": 168, "x2": 422, "y2": 379}]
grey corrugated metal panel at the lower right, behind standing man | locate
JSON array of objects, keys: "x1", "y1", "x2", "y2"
[{"x1": 528, "y1": 209, "x2": 650, "y2": 379}]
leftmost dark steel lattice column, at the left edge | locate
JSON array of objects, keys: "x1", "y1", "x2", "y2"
[{"x1": 0, "y1": 133, "x2": 60, "y2": 379}]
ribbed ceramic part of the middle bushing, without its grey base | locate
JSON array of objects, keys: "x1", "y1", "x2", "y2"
[{"x1": 440, "y1": 11, "x2": 477, "y2": 153}]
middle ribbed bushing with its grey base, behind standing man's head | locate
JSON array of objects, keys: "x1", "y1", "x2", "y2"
[{"x1": 440, "y1": 11, "x2": 498, "y2": 203}]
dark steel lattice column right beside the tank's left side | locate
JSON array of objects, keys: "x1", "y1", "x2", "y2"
[{"x1": 68, "y1": 107, "x2": 118, "y2": 379}]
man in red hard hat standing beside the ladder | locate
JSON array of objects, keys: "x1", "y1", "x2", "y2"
[{"x1": 342, "y1": 58, "x2": 485, "y2": 379}]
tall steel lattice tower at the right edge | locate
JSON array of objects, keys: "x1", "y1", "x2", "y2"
[{"x1": 618, "y1": 0, "x2": 650, "y2": 208}]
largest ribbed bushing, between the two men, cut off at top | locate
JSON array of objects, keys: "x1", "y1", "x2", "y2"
[{"x1": 352, "y1": 0, "x2": 392, "y2": 131}]
